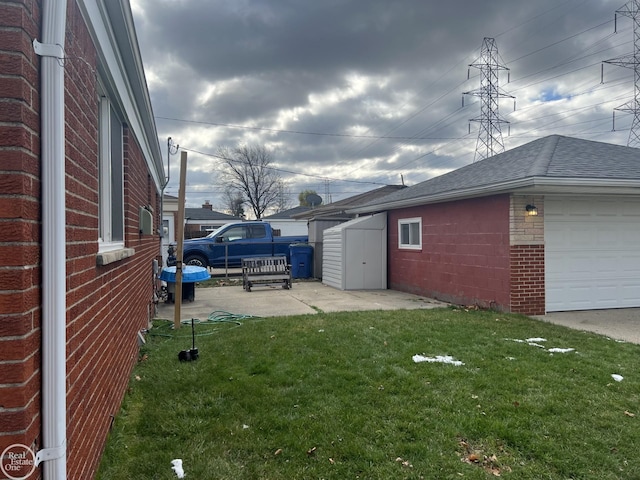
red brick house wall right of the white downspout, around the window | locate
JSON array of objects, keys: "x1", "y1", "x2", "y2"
[{"x1": 65, "y1": 2, "x2": 160, "y2": 478}]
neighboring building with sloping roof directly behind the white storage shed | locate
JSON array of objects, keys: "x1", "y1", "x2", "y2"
[{"x1": 291, "y1": 185, "x2": 406, "y2": 278}]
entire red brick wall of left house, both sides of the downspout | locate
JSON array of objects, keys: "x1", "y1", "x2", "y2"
[{"x1": 0, "y1": 0, "x2": 160, "y2": 478}]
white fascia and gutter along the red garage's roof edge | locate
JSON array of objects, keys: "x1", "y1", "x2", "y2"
[{"x1": 346, "y1": 177, "x2": 640, "y2": 214}]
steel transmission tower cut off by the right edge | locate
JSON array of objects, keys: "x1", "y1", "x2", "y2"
[{"x1": 604, "y1": 0, "x2": 640, "y2": 147}]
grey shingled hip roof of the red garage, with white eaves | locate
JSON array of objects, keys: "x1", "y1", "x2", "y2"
[{"x1": 349, "y1": 135, "x2": 640, "y2": 213}]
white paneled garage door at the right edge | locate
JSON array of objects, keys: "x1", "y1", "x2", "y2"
[{"x1": 544, "y1": 197, "x2": 640, "y2": 312}]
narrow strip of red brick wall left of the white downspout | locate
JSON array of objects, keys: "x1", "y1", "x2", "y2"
[{"x1": 0, "y1": 0, "x2": 41, "y2": 458}]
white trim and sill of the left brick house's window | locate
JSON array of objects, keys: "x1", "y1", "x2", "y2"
[{"x1": 98, "y1": 96, "x2": 124, "y2": 252}]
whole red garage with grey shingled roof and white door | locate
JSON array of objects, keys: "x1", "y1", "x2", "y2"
[{"x1": 350, "y1": 135, "x2": 640, "y2": 314}]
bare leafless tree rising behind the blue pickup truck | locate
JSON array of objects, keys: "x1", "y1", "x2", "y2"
[{"x1": 218, "y1": 145, "x2": 282, "y2": 220}]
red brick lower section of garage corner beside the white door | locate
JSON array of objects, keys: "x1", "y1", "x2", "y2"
[{"x1": 511, "y1": 245, "x2": 545, "y2": 315}]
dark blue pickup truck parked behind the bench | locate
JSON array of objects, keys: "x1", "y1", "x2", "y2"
[{"x1": 182, "y1": 221, "x2": 309, "y2": 268}]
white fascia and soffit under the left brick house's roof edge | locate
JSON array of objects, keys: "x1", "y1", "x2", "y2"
[{"x1": 77, "y1": 0, "x2": 164, "y2": 191}]
